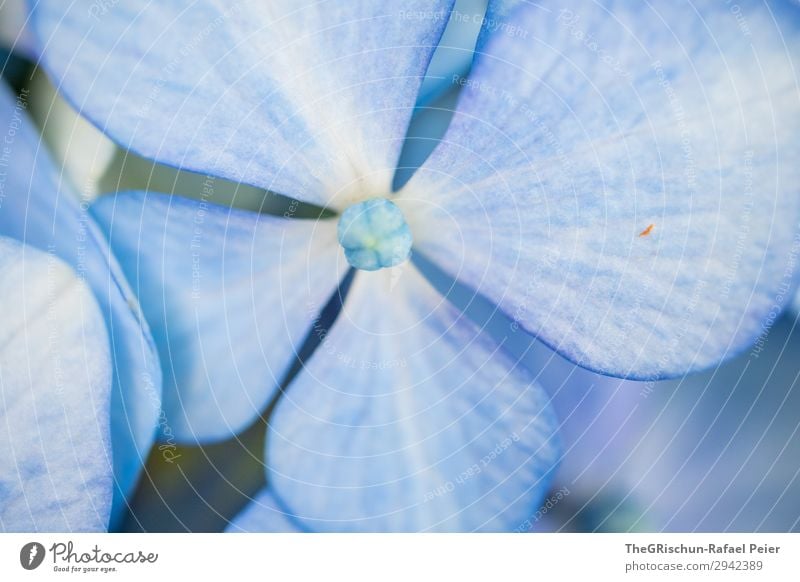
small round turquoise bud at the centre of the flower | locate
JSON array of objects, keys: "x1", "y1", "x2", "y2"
[{"x1": 337, "y1": 198, "x2": 413, "y2": 271}]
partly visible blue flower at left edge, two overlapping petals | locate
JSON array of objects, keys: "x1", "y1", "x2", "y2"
[{"x1": 0, "y1": 85, "x2": 161, "y2": 531}]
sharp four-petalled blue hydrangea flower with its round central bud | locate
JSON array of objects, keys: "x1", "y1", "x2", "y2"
[{"x1": 32, "y1": 0, "x2": 800, "y2": 530}]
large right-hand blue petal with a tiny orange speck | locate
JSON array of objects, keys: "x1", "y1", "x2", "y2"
[{"x1": 396, "y1": 2, "x2": 800, "y2": 379}]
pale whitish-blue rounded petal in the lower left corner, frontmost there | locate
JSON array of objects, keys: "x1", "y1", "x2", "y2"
[{"x1": 0, "y1": 237, "x2": 113, "y2": 532}]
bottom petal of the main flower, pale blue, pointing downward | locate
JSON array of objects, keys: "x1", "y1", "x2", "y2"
[{"x1": 266, "y1": 266, "x2": 558, "y2": 531}]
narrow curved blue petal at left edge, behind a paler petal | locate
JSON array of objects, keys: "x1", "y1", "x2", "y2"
[{"x1": 0, "y1": 87, "x2": 161, "y2": 521}]
